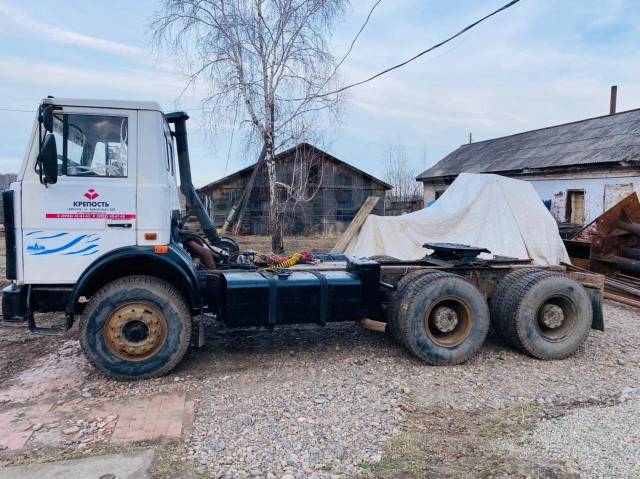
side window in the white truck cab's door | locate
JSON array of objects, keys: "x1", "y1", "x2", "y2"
[{"x1": 53, "y1": 114, "x2": 129, "y2": 178}]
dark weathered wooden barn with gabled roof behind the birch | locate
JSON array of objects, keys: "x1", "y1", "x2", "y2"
[{"x1": 198, "y1": 143, "x2": 391, "y2": 235}]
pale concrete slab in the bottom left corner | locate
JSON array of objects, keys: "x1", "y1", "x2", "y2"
[{"x1": 0, "y1": 449, "x2": 153, "y2": 479}]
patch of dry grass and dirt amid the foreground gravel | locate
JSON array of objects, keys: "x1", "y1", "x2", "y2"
[{"x1": 360, "y1": 404, "x2": 562, "y2": 479}]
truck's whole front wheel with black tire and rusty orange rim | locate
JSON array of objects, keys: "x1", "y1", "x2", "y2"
[{"x1": 80, "y1": 276, "x2": 191, "y2": 379}]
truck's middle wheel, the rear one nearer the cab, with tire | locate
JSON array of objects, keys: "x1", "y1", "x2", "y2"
[{"x1": 398, "y1": 272, "x2": 489, "y2": 365}]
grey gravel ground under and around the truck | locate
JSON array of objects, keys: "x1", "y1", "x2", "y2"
[{"x1": 0, "y1": 302, "x2": 640, "y2": 479}]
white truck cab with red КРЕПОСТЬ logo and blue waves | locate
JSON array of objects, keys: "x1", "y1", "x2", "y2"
[{"x1": 11, "y1": 98, "x2": 180, "y2": 284}]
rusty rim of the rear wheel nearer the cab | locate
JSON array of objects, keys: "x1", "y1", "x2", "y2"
[{"x1": 424, "y1": 296, "x2": 473, "y2": 348}]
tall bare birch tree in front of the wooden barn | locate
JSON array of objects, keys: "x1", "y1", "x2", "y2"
[{"x1": 151, "y1": 0, "x2": 348, "y2": 252}]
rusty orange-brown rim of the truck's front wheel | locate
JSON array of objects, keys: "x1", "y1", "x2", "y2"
[{"x1": 103, "y1": 303, "x2": 167, "y2": 361}]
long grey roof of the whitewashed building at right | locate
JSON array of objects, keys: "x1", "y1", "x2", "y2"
[{"x1": 416, "y1": 109, "x2": 640, "y2": 180}]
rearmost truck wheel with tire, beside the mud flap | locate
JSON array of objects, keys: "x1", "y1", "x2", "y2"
[{"x1": 503, "y1": 271, "x2": 593, "y2": 359}]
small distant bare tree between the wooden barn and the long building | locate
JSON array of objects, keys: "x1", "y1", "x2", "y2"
[{"x1": 384, "y1": 143, "x2": 420, "y2": 201}]
